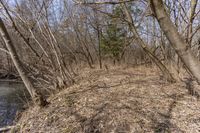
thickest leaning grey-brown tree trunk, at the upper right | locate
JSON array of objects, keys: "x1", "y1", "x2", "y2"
[{"x1": 150, "y1": 0, "x2": 200, "y2": 84}]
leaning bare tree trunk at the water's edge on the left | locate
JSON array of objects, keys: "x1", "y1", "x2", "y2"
[{"x1": 0, "y1": 18, "x2": 47, "y2": 106}]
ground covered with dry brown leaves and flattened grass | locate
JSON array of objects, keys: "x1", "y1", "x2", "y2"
[{"x1": 14, "y1": 66, "x2": 200, "y2": 133}]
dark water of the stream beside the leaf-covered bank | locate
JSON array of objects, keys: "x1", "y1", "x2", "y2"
[{"x1": 0, "y1": 82, "x2": 29, "y2": 127}]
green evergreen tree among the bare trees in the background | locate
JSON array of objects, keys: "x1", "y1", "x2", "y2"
[{"x1": 101, "y1": 6, "x2": 127, "y2": 63}]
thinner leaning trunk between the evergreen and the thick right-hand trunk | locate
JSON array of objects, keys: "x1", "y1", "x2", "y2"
[{"x1": 121, "y1": 3, "x2": 175, "y2": 82}]
